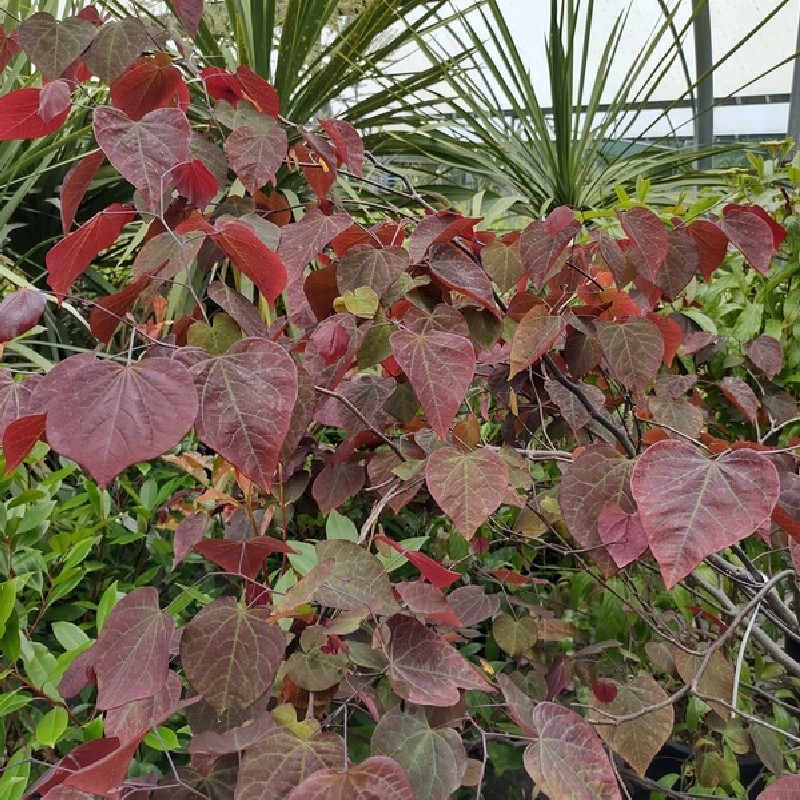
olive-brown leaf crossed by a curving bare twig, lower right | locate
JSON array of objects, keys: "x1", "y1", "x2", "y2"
[{"x1": 590, "y1": 673, "x2": 675, "y2": 775}]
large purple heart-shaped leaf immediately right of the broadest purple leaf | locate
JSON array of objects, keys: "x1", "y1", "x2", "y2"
[{"x1": 192, "y1": 339, "x2": 297, "y2": 491}]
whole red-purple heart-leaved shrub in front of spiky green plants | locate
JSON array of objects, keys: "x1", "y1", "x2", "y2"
[{"x1": 0, "y1": 0, "x2": 800, "y2": 800}]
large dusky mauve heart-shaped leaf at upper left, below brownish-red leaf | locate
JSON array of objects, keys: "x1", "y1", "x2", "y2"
[{"x1": 92, "y1": 106, "x2": 191, "y2": 211}]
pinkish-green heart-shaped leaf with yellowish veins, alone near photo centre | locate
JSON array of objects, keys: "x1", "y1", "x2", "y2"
[{"x1": 425, "y1": 446, "x2": 509, "y2": 539}]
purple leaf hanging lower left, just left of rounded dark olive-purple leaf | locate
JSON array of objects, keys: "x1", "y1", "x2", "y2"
[{"x1": 94, "y1": 586, "x2": 175, "y2": 710}]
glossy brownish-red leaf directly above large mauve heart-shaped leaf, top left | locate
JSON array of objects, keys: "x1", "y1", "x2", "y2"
[{"x1": 111, "y1": 53, "x2": 189, "y2": 120}]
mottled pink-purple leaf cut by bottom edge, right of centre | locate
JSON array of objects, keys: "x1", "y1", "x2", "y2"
[{"x1": 524, "y1": 702, "x2": 622, "y2": 800}]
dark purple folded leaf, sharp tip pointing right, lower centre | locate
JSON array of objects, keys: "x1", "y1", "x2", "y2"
[{"x1": 386, "y1": 614, "x2": 494, "y2": 707}]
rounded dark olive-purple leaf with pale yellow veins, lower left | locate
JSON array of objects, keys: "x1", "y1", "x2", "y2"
[{"x1": 181, "y1": 597, "x2": 286, "y2": 712}]
